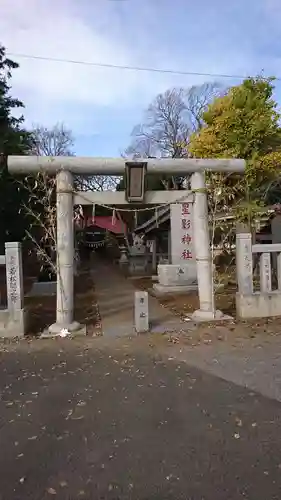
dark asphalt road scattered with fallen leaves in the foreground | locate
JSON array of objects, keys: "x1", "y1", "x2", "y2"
[{"x1": 0, "y1": 336, "x2": 281, "y2": 500}]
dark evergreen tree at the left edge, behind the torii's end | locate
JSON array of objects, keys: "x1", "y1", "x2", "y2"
[{"x1": 0, "y1": 46, "x2": 31, "y2": 253}]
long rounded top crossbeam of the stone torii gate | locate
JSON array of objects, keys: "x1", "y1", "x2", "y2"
[{"x1": 8, "y1": 156, "x2": 245, "y2": 176}]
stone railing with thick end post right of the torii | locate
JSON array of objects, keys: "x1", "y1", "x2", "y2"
[{"x1": 236, "y1": 233, "x2": 281, "y2": 318}]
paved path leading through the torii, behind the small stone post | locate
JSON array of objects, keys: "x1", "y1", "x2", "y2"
[{"x1": 92, "y1": 260, "x2": 187, "y2": 337}]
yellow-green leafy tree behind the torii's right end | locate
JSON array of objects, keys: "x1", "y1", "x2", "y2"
[{"x1": 189, "y1": 77, "x2": 281, "y2": 218}]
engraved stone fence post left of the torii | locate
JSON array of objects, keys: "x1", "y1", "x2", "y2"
[{"x1": 0, "y1": 242, "x2": 26, "y2": 337}]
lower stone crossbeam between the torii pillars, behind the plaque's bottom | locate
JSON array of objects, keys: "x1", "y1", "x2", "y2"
[{"x1": 74, "y1": 190, "x2": 194, "y2": 209}]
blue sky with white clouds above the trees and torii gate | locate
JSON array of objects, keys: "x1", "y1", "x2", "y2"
[{"x1": 0, "y1": 0, "x2": 281, "y2": 156}]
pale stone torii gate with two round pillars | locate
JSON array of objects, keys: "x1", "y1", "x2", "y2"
[{"x1": 8, "y1": 156, "x2": 245, "y2": 334}]
